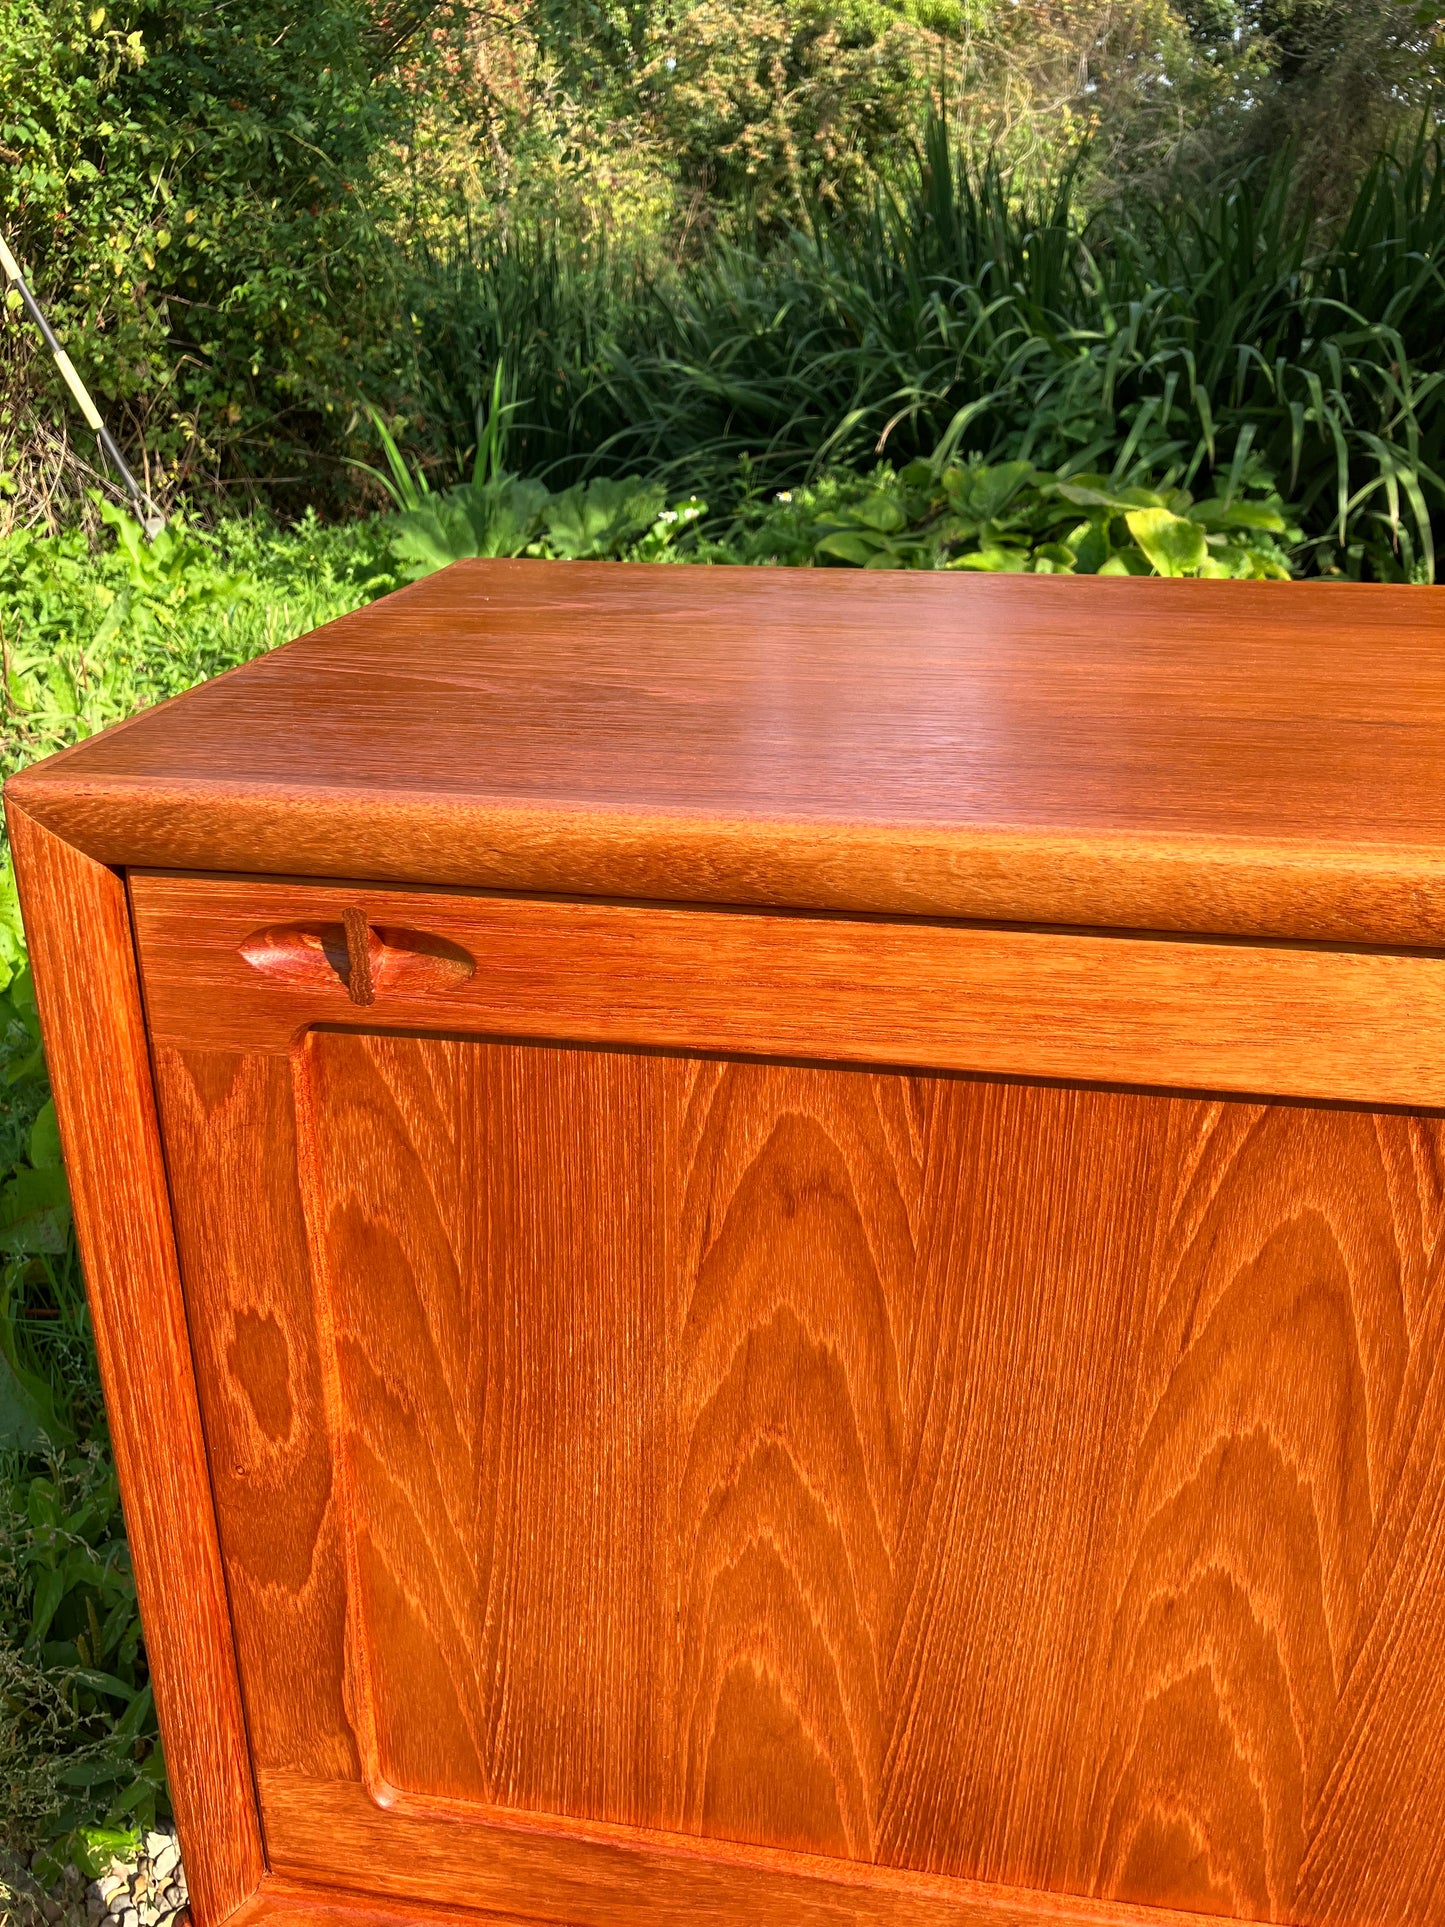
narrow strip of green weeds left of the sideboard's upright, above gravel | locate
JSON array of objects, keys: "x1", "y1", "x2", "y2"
[{"x1": 0, "y1": 863, "x2": 151, "y2": 1871}]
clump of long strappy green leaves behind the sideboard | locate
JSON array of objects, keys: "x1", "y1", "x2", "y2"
[{"x1": 416, "y1": 121, "x2": 1445, "y2": 580}]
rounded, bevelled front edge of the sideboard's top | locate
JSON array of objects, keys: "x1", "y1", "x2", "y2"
[{"x1": 6, "y1": 767, "x2": 1445, "y2": 948}]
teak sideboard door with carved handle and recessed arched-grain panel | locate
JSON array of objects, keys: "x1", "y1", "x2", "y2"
[{"x1": 133, "y1": 877, "x2": 1445, "y2": 1927}]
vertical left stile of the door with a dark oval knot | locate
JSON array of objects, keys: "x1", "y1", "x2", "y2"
[{"x1": 154, "y1": 1046, "x2": 360, "y2": 1779}]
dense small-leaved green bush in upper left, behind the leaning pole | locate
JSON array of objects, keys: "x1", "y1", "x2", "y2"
[{"x1": 0, "y1": 0, "x2": 466, "y2": 504}]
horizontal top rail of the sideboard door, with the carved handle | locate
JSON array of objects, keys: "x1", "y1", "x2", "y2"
[{"x1": 131, "y1": 873, "x2": 1445, "y2": 1106}]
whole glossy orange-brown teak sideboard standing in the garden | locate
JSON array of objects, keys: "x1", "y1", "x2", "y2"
[{"x1": 6, "y1": 563, "x2": 1445, "y2": 1927}]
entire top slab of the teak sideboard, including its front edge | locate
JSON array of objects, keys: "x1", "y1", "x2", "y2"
[{"x1": 8, "y1": 561, "x2": 1445, "y2": 942}]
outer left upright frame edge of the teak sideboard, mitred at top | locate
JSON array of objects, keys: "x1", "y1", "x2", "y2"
[{"x1": 6, "y1": 804, "x2": 262, "y2": 1927}]
